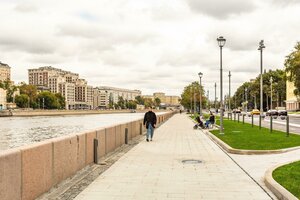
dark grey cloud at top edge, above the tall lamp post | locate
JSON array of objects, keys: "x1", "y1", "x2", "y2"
[{"x1": 187, "y1": 0, "x2": 256, "y2": 19}]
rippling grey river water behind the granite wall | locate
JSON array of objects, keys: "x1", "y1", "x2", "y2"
[{"x1": 0, "y1": 113, "x2": 163, "y2": 152}]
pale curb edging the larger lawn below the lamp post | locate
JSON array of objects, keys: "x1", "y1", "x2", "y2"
[{"x1": 202, "y1": 130, "x2": 300, "y2": 155}]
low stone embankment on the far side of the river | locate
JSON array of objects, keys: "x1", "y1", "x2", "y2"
[{"x1": 0, "y1": 110, "x2": 165, "y2": 117}]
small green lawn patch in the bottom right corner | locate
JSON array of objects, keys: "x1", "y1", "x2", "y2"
[{"x1": 273, "y1": 161, "x2": 300, "y2": 199}]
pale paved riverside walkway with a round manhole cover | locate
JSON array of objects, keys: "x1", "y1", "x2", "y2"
[{"x1": 76, "y1": 114, "x2": 270, "y2": 200}]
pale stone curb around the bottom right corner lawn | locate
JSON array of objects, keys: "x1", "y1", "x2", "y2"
[{"x1": 264, "y1": 161, "x2": 298, "y2": 200}]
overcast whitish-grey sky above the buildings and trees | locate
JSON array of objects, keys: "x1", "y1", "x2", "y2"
[{"x1": 0, "y1": 0, "x2": 300, "y2": 99}]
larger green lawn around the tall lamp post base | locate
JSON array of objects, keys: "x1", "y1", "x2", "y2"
[{"x1": 211, "y1": 119, "x2": 300, "y2": 150}]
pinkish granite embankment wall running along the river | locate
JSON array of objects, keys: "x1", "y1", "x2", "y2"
[{"x1": 0, "y1": 113, "x2": 174, "y2": 200}]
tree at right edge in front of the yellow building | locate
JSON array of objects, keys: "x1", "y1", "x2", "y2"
[{"x1": 284, "y1": 42, "x2": 300, "y2": 97}]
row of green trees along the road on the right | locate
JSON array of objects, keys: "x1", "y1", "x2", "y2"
[{"x1": 181, "y1": 42, "x2": 300, "y2": 111}]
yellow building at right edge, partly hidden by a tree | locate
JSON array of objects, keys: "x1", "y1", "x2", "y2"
[{"x1": 286, "y1": 81, "x2": 300, "y2": 111}]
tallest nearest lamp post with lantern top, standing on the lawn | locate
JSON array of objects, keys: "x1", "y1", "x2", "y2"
[{"x1": 217, "y1": 36, "x2": 226, "y2": 134}]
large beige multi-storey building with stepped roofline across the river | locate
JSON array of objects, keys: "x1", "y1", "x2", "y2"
[{"x1": 28, "y1": 66, "x2": 93, "y2": 109}]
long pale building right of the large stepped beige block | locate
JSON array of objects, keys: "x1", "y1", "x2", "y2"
[{"x1": 93, "y1": 86, "x2": 142, "y2": 108}]
